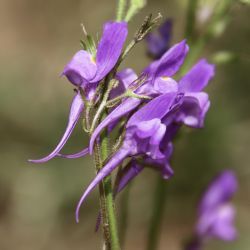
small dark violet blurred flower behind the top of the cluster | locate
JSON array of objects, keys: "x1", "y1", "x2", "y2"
[{"x1": 146, "y1": 19, "x2": 173, "y2": 59}]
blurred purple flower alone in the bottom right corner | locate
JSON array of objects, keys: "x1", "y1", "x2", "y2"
[{"x1": 186, "y1": 170, "x2": 238, "y2": 250}]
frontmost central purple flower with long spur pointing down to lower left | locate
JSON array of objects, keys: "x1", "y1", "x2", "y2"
[{"x1": 76, "y1": 92, "x2": 182, "y2": 221}]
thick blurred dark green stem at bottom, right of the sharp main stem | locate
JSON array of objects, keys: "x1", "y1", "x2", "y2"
[{"x1": 147, "y1": 176, "x2": 167, "y2": 250}]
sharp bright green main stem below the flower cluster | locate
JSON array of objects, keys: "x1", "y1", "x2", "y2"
[{"x1": 100, "y1": 118, "x2": 120, "y2": 250}]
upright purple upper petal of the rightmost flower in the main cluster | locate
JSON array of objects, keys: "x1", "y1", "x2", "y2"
[{"x1": 179, "y1": 59, "x2": 215, "y2": 92}]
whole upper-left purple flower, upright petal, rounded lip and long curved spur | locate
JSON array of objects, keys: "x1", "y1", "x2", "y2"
[{"x1": 30, "y1": 22, "x2": 128, "y2": 163}]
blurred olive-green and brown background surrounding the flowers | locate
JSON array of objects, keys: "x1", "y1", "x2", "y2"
[{"x1": 0, "y1": 0, "x2": 250, "y2": 250}]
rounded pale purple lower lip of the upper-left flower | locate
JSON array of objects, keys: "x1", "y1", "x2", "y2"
[{"x1": 62, "y1": 50, "x2": 97, "y2": 86}]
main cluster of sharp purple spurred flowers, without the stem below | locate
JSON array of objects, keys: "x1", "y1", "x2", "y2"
[{"x1": 30, "y1": 19, "x2": 214, "y2": 224}]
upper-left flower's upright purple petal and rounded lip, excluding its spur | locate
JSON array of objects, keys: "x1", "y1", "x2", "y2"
[{"x1": 62, "y1": 22, "x2": 128, "y2": 99}]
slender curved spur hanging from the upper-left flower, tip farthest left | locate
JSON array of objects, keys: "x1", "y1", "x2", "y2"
[{"x1": 29, "y1": 93, "x2": 84, "y2": 163}]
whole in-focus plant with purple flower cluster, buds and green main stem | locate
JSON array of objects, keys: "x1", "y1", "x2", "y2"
[{"x1": 30, "y1": 0, "x2": 239, "y2": 250}]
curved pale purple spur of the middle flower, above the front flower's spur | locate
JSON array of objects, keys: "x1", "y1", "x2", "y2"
[{"x1": 89, "y1": 98, "x2": 141, "y2": 154}]
